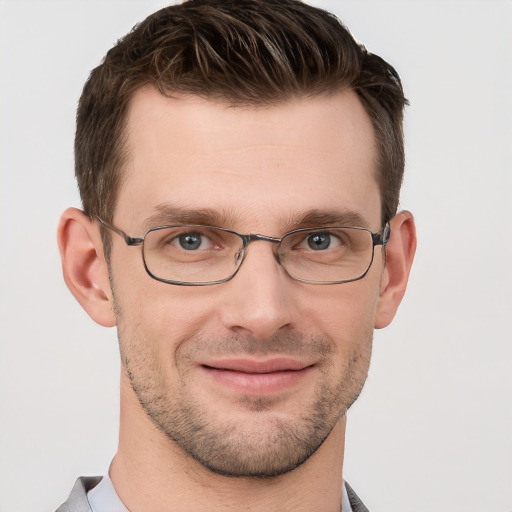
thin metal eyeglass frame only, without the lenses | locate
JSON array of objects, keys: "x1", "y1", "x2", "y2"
[{"x1": 95, "y1": 215, "x2": 391, "y2": 286}]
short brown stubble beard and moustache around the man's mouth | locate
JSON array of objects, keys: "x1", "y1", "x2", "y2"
[{"x1": 118, "y1": 318, "x2": 373, "y2": 478}]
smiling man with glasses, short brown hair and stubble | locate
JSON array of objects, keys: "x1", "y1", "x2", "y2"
[{"x1": 58, "y1": 0, "x2": 416, "y2": 512}]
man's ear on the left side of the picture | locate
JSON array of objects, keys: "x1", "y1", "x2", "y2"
[{"x1": 57, "y1": 208, "x2": 116, "y2": 327}]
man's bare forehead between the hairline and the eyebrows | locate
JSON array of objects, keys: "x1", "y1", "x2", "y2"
[{"x1": 115, "y1": 87, "x2": 380, "y2": 231}]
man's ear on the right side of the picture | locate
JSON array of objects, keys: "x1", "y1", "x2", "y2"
[{"x1": 375, "y1": 211, "x2": 416, "y2": 329}]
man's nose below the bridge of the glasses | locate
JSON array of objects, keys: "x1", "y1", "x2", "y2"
[{"x1": 220, "y1": 241, "x2": 297, "y2": 339}]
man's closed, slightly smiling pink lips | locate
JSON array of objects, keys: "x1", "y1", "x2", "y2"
[{"x1": 201, "y1": 358, "x2": 314, "y2": 395}]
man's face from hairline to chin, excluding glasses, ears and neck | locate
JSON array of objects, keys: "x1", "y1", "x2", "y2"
[{"x1": 111, "y1": 88, "x2": 383, "y2": 476}]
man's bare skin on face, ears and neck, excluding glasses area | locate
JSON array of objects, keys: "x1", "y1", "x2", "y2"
[{"x1": 59, "y1": 88, "x2": 415, "y2": 512}]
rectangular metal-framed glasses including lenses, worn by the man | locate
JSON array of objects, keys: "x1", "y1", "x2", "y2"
[{"x1": 98, "y1": 217, "x2": 391, "y2": 286}]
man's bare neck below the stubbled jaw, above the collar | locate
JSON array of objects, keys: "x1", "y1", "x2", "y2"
[{"x1": 110, "y1": 372, "x2": 345, "y2": 512}]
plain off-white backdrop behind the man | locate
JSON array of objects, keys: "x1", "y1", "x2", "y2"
[{"x1": 0, "y1": 0, "x2": 512, "y2": 512}]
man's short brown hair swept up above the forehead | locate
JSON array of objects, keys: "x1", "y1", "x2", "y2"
[{"x1": 75, "y1": 0, "x2": 407, "y2": 230}]
